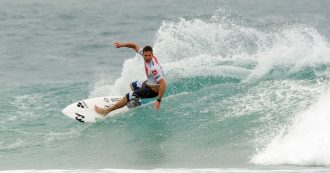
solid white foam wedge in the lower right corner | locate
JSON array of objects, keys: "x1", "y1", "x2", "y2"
[{"x1": 251, "y1": 92, "x2": 330, "y2": 165}]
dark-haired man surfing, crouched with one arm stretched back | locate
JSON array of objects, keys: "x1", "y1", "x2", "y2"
[{"x1": 95, "y1": 42, "x2": 166, "y2": 116}]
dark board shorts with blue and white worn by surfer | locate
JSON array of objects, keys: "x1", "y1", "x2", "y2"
[{"x1": 126, "y1": 81, "x2": 158, "y2": 102}]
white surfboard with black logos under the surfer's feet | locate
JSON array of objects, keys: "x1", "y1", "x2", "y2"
[{"x1": 62, "y1": 96, "x2": 141, "y2": 123}]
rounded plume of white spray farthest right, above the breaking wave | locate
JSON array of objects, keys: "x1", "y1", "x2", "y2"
[{"x1": 247, "y1": 26, "x2": 330, "y2": 80}]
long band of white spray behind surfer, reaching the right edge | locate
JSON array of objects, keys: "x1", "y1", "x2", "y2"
[{"x1": 91, "y1": 19, "x2": 330, "y2": 96}]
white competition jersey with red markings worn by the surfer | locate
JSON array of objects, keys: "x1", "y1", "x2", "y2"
[{"x1": 138, "y1": 48, "x2": 164, "y2": 85}]
